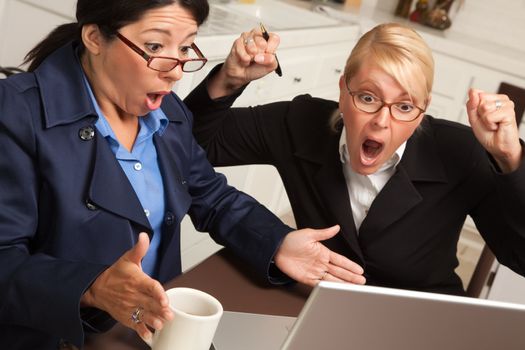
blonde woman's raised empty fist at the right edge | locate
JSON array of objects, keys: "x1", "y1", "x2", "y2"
[{"x1": 467, "y1": 89, "x2": 522, "y2": 173}]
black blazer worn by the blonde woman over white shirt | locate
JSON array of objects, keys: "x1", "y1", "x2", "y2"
[{"x1": 185, "y1": 74, "x2": 525, "y2": 294}]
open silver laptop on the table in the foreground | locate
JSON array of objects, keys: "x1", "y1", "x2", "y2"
[{"x1": 214, "y1": 281, "x2": 525, "y2": 350}]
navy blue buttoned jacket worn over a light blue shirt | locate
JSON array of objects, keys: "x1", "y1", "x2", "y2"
[{"x1": 0, "y1": 44, "x2": 291, "y2": 350}]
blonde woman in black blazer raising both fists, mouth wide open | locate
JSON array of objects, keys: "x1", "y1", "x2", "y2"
[{"x1": 186, "y1": 24, "x2": 525, "y2": 295}]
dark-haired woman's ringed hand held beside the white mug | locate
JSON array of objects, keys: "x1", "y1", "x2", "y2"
[{"x1": 81, "y1": 232, "x2": 173, "y2": 339}]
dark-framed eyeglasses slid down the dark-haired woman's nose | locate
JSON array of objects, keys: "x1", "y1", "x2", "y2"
[{"x1": 117, "y1": 33, "x2": 208, "y2": 73}]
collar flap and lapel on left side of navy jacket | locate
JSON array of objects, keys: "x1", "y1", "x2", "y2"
[{"x1": 35, "y1": 42, "x2": 152, "y2": 232}]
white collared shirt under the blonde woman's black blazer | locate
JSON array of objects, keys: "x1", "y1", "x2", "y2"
[{"x1": 339, "y1": 127, "x2": 406, "y2": 233}]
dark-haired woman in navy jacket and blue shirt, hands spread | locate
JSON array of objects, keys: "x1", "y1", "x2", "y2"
[{"x1": 0, "y1": 0, "x2": 364, "y2": 350}]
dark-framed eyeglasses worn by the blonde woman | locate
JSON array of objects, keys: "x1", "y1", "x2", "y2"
[{"x1": 346, "y1": 83, "x2": 426, "y2": 122}]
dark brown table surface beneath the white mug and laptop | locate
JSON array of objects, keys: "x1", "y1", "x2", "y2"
[{"x1": 84, "y1": 249, "x2": 311, "y2": 350}]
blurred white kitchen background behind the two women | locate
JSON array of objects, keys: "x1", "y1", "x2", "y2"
[{"x1": 0, "y1": 0, "x2": 525, "y2": 303}]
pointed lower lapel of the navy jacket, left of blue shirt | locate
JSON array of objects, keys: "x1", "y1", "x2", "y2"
[{"x1": 89, "y1": 132, "x2": 152, "y2": 232}]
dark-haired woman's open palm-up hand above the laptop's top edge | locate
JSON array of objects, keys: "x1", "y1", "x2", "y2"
[{"x1": 275, "y1": 225, "x2": 366, "y2": 286}]
